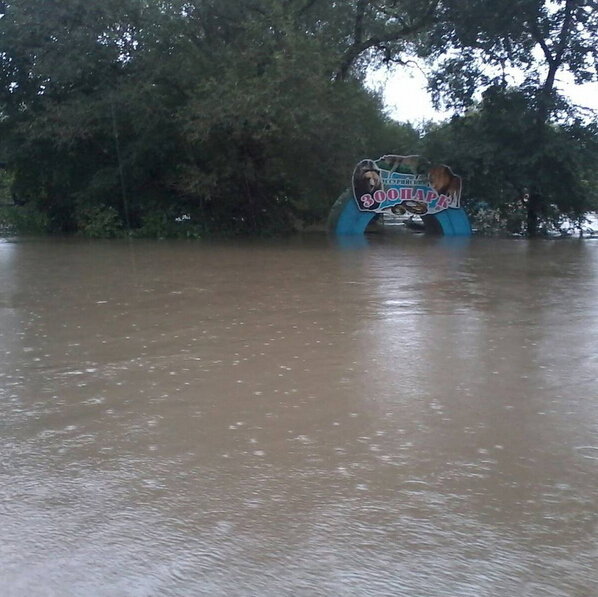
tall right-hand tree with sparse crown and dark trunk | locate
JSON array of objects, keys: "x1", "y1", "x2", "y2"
[{"x1": 422, "y1": 0, "x2": 598, "y2": 235}]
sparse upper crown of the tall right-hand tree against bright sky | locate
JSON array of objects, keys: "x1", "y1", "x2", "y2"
[{"x1": 419, "y1": 0, "x2": 598, "y2": 115}]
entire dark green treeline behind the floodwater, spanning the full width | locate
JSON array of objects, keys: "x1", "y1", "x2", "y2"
[{"x1": 0, "y1": 0, "x2": 598, "y2": 236}]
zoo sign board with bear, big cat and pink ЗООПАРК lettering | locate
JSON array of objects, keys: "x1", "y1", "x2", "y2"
[{"x1": 353, "y1": 155, "x2": 461, "y2": 216}]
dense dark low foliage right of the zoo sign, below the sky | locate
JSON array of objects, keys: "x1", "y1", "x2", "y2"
[{"x1": 423, "y1": 87, "x2": 598, "y2": 232}]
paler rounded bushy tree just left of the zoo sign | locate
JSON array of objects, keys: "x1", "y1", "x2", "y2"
[{"x1": 172, "y1": 2, "x2": 417, "y2": 231}]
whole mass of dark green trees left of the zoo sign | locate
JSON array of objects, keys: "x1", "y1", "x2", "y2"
[{"x1": 0, "y1": 0, "x2": 417, "y2": 233}]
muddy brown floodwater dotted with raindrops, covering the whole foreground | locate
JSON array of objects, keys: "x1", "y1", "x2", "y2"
[{"x1": 0, "y1": 234, "x2": 598, "y2": 597}]
